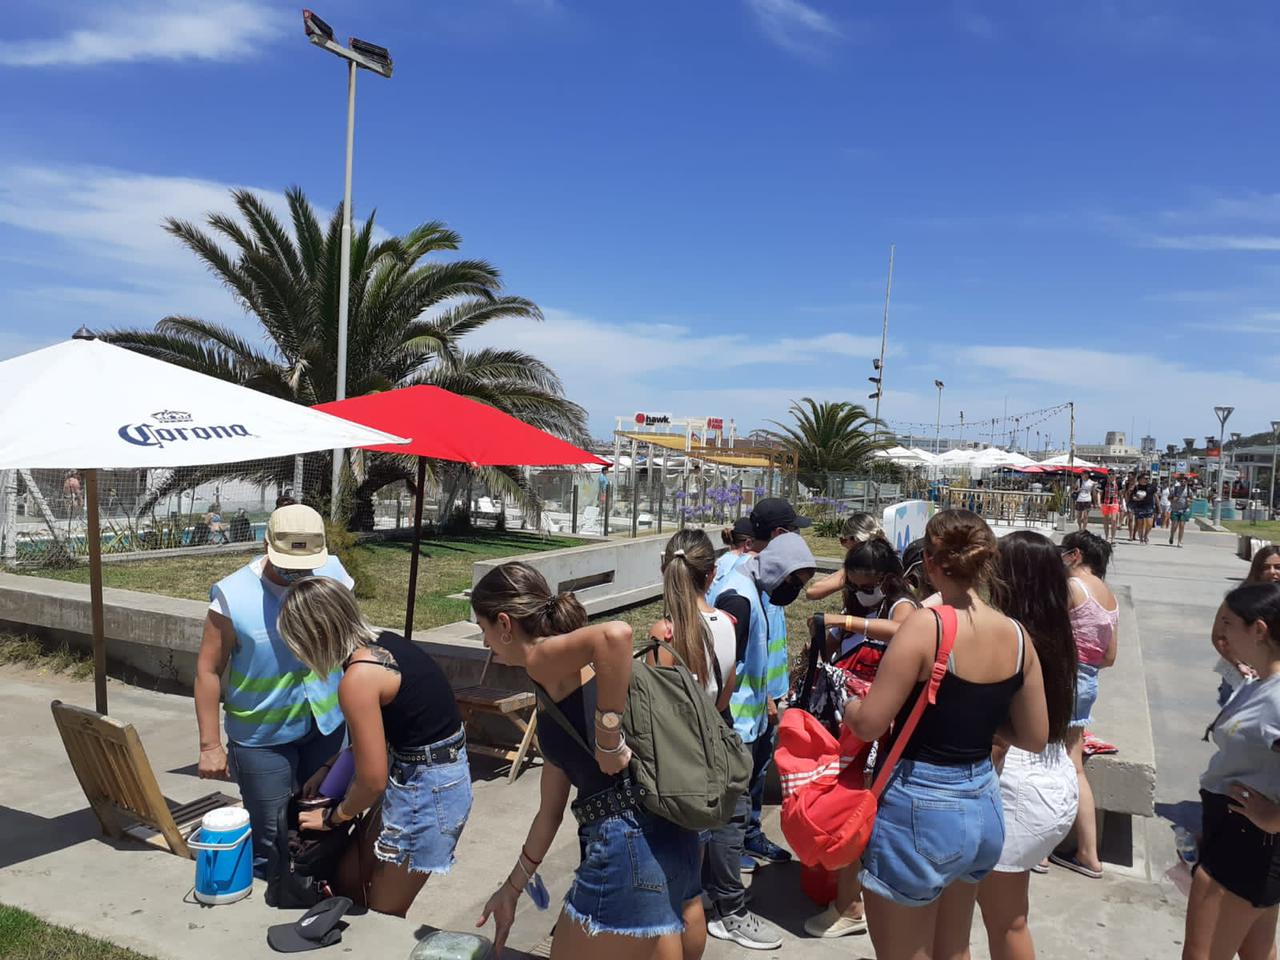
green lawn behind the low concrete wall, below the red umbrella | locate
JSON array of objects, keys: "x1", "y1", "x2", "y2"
[{"x1": 13, "y1": 530, "x2": 581, "y2": 640}]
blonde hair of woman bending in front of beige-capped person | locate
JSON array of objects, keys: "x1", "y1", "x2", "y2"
[{"x1": 276, "y1": 577, "x2": 378, "y2": 677}]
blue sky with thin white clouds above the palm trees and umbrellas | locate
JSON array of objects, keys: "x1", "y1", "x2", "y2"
[{"x1": 0, "y1": 0, "x2": 1280, "y2": 445}]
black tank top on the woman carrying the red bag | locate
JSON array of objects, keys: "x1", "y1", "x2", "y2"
[{"x1": 878, "y1": 626, "x2": 1027, "y2": 767}]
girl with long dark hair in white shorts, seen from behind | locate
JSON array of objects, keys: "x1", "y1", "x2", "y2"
[{"x1": 978, "y1": 531, "x2": 1079, "y2": 960}]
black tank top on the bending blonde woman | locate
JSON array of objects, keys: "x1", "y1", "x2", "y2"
[{"x1": 343, "y1": 631, "x2": 462, "y2": 751}]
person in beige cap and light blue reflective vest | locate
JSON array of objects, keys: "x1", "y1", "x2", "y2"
[{"x1": 196, "y1": 503, "x2": 355, "y2": 878}]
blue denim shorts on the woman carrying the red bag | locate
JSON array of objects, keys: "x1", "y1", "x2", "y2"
[{"x1": 859, "y1": 759, "x2": 1005, "y2": 906}]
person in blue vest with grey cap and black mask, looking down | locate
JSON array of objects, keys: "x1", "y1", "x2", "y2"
[{"x1": 704, "y1": 514, "x2": 814, "y2": 950}]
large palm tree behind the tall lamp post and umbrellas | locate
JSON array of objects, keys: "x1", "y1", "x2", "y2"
[{"x1": 101, "y1": 187, "x2": 588, "y2": 522}]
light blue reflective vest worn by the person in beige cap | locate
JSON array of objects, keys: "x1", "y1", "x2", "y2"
[{"x1": 210, "y1": 557, "x2": 346, "y2": 746}]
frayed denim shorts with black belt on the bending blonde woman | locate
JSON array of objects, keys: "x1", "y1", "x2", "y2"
[{"x1": 374, "y1": 730, "x2": 471, "y2": 873}]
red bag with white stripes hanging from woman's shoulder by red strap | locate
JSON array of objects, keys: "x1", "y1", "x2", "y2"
[{"x1": 774, "y1": 607, "x2": 956, "y2": 870}]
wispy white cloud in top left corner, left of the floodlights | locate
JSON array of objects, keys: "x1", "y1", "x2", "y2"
[{"x1": 0, "y1": 0, "x2": 285, "y2": 67}]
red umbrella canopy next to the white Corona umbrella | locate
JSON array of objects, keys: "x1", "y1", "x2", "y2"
[{"x1": 316, "y1": 385, "x2": 609, "y2": 467}]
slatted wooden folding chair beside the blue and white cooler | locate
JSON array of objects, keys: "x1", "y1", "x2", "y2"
[{"x1": 50, "y1": 700, "x2": 241, "y2": 859}]
